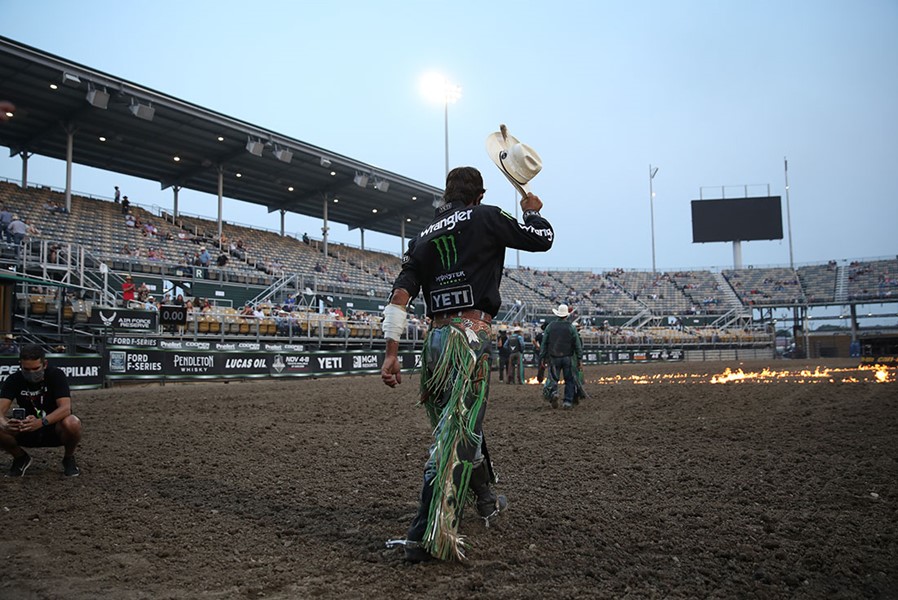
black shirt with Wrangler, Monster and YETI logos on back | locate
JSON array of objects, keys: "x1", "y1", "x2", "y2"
[{"x1": 393, "y1": 202, "x2": 555, "y2": 317}]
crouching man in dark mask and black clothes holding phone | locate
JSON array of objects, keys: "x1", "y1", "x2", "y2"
[{"x1": 0, "y1": 344, "x2": 81, "y2": 477}]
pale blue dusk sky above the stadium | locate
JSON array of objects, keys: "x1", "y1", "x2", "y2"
[{"x1": 0, "y1": 0, "x2": 898, "y2": 270}]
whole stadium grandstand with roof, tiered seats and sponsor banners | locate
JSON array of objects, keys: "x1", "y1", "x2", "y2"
[{"x1": 0, "y1": 38, "x2": 898, "y2": 386}]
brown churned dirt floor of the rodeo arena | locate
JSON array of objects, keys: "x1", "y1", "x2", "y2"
[{"x1": 0, "y1": 360, "x2": 898, "y2": 600}]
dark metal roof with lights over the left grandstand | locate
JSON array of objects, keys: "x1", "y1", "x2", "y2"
[{"x1": 0, "y1": 36, "x2": 443, "y2": 237}]
